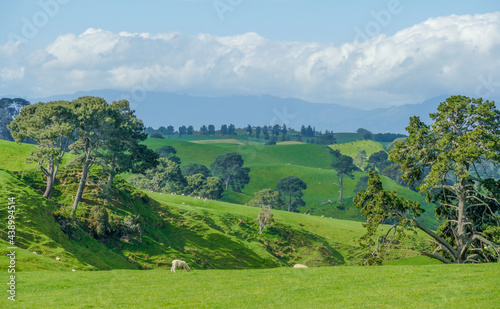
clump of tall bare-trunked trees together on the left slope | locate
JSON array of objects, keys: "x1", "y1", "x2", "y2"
[{"x1": 8, "y1": 96, "x2": 158, "y2": 214}]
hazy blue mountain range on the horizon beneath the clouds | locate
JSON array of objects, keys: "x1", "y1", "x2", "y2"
[{"x1": 21, "y1": 90, "x2": 456, "y2": 133}]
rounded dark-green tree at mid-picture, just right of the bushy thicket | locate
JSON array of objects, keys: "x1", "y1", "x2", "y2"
[{"x1": 210, "y1": 152, "x2": 250, "y2": 192}]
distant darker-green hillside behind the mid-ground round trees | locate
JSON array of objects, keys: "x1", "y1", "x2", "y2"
[{"x1": 142, "y1": 137, "x2": 436, "y2": 227}]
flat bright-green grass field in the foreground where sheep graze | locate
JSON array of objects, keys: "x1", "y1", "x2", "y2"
[{"x1": 8, "y1": 263, "x2": 500, "y2": 308}]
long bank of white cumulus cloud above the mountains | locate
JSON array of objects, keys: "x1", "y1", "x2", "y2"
[{"x1": 0, "y1": 13, "x2": 500, "y2": 107}]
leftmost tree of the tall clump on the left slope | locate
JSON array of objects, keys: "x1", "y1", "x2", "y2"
[{"x1": 8, "y1": 101, "x2": 76, "y2": 199}]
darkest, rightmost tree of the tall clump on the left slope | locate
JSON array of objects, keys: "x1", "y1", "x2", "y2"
[{"x1": 98, "y1": 100, "x2": 158, "y2": 188}]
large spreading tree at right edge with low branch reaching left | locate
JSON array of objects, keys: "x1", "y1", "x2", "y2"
[{"x1": 355, "y1": 96, "x2": 500, "y2": 263}]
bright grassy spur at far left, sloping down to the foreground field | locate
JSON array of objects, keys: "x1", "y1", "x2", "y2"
[{"x1": 0, "y1": 170, "x2": 137, "y2": 271}]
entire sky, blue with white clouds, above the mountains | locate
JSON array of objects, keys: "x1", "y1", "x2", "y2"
[{"x1": 0, "y1": 0, "x2": 500, "y2": 109}]
